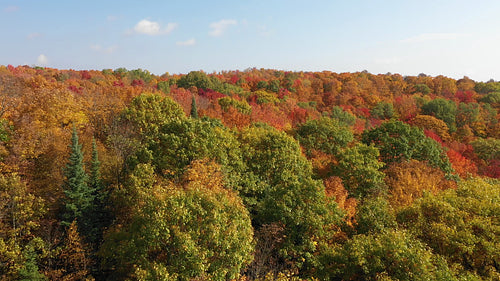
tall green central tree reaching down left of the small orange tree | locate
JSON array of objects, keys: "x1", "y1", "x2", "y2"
[{"x1": 240, "y1": 126, "x2": 340, "y2": 270}]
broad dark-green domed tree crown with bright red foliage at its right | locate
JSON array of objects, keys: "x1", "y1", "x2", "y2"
[{"x1": 362, "y1": 121, "x2": 452, "y2": 173}]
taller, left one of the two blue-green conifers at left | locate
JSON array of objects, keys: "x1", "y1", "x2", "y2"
[{"x1": 61, "y1": 127, "x2": 93, "y2": 226}]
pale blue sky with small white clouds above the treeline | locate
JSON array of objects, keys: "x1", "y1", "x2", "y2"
[{"x1": 0, "y1": 0, "x2": 500, "y2": 81}]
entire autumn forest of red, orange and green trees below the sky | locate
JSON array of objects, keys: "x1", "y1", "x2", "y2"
[{"x1": 0, "y1": 65, "x2": 500, "y2": 281}]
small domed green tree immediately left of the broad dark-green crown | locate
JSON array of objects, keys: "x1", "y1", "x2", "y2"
[{"x1": 295, "y1": 117, "x2": 354, "y2": 155}]
